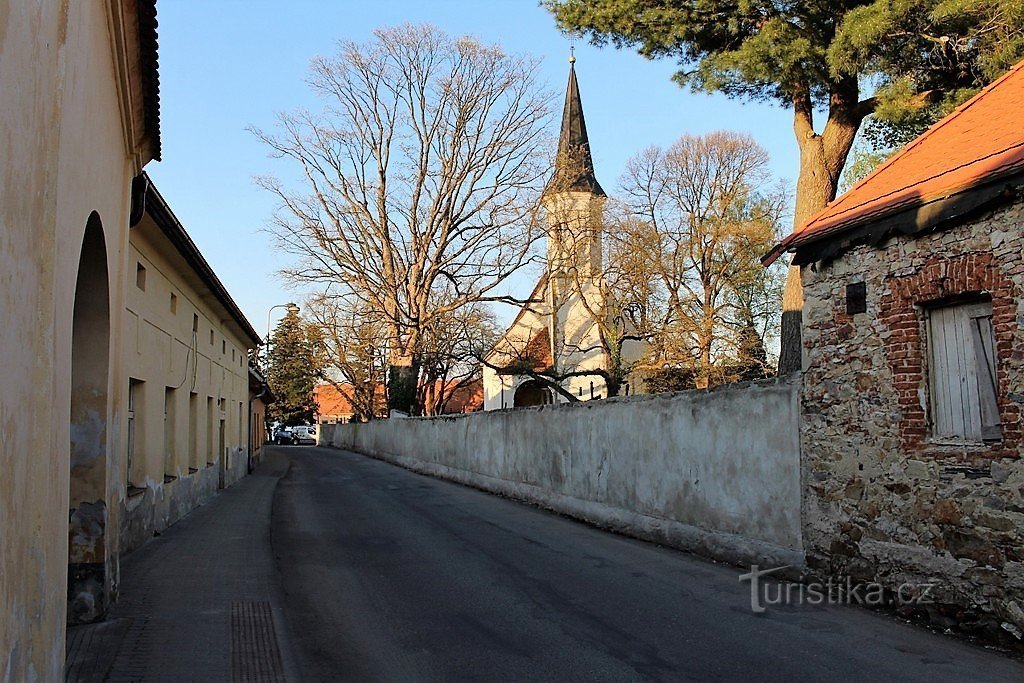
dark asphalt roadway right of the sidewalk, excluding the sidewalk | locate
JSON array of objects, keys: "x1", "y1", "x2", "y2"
[{"x1": 271, "y1": 446, "x2": 1024, "y2": 681}]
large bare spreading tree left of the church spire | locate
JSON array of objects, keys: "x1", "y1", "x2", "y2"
[{"x1": 255, "y1": 25, "x2": 551, "y2": 411}]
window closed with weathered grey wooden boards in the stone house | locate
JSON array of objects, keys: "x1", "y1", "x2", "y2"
[{"x1": 928, "y1": 301, "x2": 1002, "y2": 443}]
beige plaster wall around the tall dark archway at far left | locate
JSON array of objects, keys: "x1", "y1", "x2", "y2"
[{"x1": 0, "y1": 1, "x2": 147, "y2": 680}]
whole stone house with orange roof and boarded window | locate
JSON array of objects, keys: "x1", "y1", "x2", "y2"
[{"x1": 766, "y1": 62, "x2": 1024, "y2": 639}]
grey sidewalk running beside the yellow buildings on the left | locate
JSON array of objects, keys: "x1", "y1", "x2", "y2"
[{"x1": 65, "y1": 450, "x2": 297, "y2": 681}]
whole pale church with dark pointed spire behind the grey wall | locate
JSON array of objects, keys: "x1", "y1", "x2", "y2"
[{"x1": 483, "y1": 57, "x2": 646, "y2": 411}]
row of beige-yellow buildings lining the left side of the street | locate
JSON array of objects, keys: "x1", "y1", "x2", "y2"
[{"x1": 0, "y1": 0, "x2": 267, "y2": 681}]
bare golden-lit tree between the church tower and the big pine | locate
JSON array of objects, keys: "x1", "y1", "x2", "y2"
[{"x1": 622, "y1": 131, "x2": 784, "y2": 386}]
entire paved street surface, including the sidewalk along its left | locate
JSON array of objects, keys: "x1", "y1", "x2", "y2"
[{"x1": 67, "y1": 446, "x2": 1024, "y2": 681}]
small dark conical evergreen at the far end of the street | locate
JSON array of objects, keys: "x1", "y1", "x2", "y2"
[{"x1": 266, "y1": 310, "x2": 318, "y2": 426}]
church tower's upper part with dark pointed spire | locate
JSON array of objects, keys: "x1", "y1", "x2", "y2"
[{"x1": 541, "y1": 56, "x2": 607, "y2": 279}]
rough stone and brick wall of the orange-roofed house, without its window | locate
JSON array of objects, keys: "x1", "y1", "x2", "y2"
[{"x1": 801, "y1": 196, "x2": 1024, "y2": 641}]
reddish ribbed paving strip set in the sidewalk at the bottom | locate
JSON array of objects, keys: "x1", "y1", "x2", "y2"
[{"x1": 231, "y1": 602, "x2": 285, "y2": 683}]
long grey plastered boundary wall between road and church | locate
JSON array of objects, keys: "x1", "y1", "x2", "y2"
[{"x1": 321, "y1": 382, "x2": 803, "y2": 566}]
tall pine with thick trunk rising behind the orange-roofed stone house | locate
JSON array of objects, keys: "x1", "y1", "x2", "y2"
[{"x1": 543, "y1": 0, "x2": 1024, "y2": 372}]
